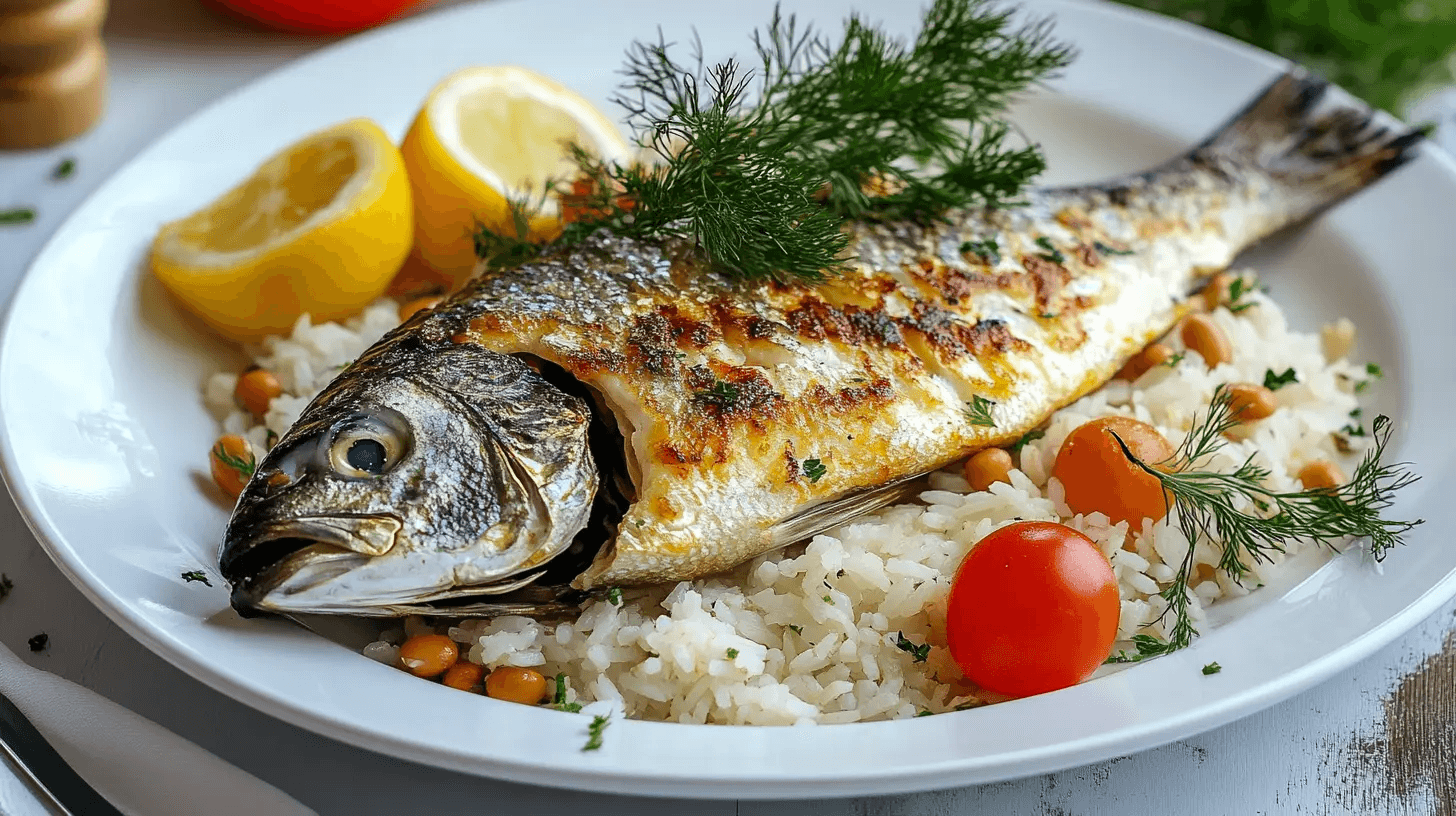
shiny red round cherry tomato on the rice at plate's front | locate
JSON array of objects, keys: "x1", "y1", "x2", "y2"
[{"x1": 945, "y1": 522, "x2": 1121, "y2": 697}]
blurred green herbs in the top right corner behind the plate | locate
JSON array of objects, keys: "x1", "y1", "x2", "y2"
[{"x1": 1118, "y1": 0, "x2": 1456, "y2": 115}]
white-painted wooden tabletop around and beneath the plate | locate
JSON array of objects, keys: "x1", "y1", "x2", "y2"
[{"x1": 0, "y1": 0, "x2": 1456, "y2": 816}]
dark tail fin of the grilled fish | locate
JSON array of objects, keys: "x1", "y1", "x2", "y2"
[{"x1": 1188, "y1": 68, "x2": 1424, "y2": 206}]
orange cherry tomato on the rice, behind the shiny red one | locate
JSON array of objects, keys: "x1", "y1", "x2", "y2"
[{"x1": 1051, "y1": 417, "x2": 1174, "y2": 529}]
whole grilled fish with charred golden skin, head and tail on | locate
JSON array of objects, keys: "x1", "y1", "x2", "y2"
[{"x1": 220, "y1": 73, "x2": 1420, "y2": 615}]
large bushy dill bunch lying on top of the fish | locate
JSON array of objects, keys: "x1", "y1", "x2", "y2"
[{"x1": 476, "y1": 0, "x2": 1072, "y2": 281}]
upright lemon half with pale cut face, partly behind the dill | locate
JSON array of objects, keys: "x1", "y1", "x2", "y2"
[{"x1": 400, "y1": 66, "x2": 629, "y2": 286}]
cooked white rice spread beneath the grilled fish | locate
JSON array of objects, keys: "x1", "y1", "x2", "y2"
[{"x1": 204, "y1": 275, "x2": 1367, "y2": 726}]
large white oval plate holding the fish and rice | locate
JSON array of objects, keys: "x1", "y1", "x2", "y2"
[{"x1": 0, "y1": 0, "x2": 1456, "y2": 797}]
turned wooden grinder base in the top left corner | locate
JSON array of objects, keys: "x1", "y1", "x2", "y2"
[{"x1": 0, "y1": 0, "x2": 106, "y2": 149}]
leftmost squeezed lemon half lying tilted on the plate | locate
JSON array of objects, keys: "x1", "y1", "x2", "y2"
[{"x1": 151, "y1": 119, "x2": 414, "y2": 341}]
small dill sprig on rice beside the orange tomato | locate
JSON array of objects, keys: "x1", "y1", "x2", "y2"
[{"x1": 1109, "y1": 386, "x2": 1424, "y2": 663}]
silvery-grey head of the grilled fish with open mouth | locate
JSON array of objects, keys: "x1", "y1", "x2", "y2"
[{"x1": 220, "y1": 335, "x2": 597, "y2": 616}]
